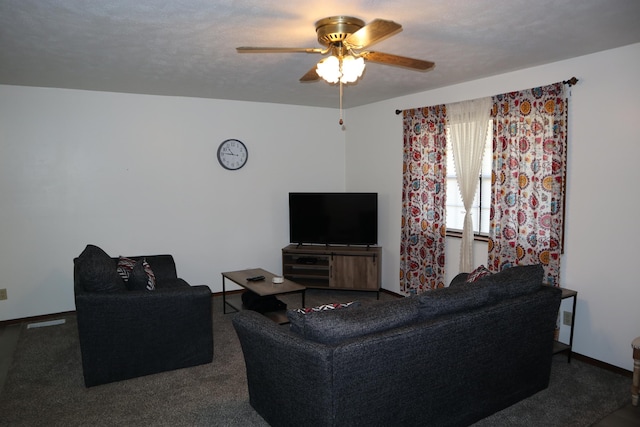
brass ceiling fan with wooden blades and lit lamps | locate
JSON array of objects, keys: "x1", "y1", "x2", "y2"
[{"x1": 236, "y1": 16, "x2": 435, "y2": 84}]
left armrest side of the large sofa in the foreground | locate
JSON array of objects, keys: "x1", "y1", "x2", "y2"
[{"x1": 233, "y1": 310, "x2": 334, "y2": 426}]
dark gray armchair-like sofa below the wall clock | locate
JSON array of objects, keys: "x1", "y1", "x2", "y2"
[{"x1": 74, "y1": 245, "x2": 213, "y2": 387}]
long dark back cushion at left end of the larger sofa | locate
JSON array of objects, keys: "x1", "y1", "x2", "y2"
[{"x1": 287, "y1": 297, "x2": 419, "y2": 344}]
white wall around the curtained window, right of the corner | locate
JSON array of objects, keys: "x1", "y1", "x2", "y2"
[{"x1": 346, "y1": 44, "x2": 640, "y2": 370}]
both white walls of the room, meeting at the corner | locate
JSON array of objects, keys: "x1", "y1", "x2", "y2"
[{"x1": 0, "y1": 44, "x2": 640, "y2": 370}]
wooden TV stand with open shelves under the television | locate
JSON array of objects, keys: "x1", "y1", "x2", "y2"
[{"x1": 282, "y1": 244, "x2": 382, "y2": 293}]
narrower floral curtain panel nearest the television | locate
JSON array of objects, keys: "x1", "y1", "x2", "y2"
[{"x1": 400, "y1": 105, "x2": 447, "y2": 294}]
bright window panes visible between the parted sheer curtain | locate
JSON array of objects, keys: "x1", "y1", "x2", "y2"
[{"x1": 447, "y1": 121, "x2": 493, "y2": 236}]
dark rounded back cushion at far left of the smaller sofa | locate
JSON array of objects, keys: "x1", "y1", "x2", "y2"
[{"x1": 74, "y1": 245, "x2": 126, "y2": 292}]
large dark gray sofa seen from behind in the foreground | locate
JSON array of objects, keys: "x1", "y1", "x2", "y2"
[{"x1": 233, "y1": 266, "x2": 561, "y2": 426}]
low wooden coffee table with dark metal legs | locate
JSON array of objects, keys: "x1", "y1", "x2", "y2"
[{"x1": 222, "y1": 268, "x2": 307, "y2": 323}]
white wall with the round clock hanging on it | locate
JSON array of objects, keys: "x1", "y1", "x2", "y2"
[{"x1": 0, "y1": 86, "x2": 345, "y2": 321}]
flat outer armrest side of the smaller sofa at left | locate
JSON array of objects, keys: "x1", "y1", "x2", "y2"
[{"x1": 75, "y1": 285, "x2": 213, "y2": 387}]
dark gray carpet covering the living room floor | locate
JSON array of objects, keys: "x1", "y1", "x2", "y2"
[{"x1": 0, "y1": 291, "x2": 630, "y2": 427}]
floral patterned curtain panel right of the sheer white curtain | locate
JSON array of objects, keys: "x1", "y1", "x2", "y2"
[{"x1": 488, "y1": 83, "x2": 567, "y2": 286}]
